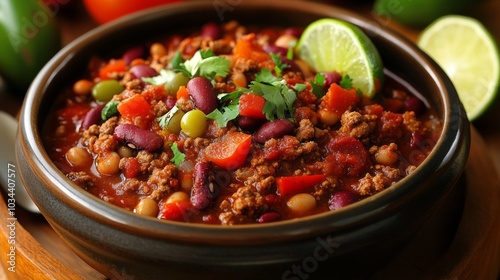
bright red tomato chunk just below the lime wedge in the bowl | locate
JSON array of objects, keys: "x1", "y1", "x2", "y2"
[{"x1": 321, "y1": 83, "x2": 361, "y2": 115}]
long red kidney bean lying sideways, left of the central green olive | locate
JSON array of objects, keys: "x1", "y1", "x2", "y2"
[{"x1": 113, "y1": 124, "x2": 163, "y2": 152}]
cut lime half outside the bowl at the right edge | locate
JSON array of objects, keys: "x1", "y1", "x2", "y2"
[{"x1": 417, "y1": 15, "x2": 500, "y2": 121}]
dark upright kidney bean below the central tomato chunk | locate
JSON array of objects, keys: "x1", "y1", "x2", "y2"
[{"x1": 190, "y1": 161, "x2": 218, "y2": 210}]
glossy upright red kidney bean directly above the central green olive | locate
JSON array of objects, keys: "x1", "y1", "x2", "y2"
[{"x1": 186, "y1": 77, "x2": 219, "y2": 114}]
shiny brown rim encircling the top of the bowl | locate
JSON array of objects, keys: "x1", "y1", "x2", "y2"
[{"x1": 19, "y1": 0, "x2": 464, "y2": 244}]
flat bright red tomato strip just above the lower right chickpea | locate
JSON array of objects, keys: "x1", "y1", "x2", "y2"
[{"x1": 276, "y1": 174, "x2": 326, "y2": 195}]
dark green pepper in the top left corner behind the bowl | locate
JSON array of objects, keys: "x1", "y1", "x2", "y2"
[{"x1": 0, "y1": 0, "x2": 61, "y2": 93}]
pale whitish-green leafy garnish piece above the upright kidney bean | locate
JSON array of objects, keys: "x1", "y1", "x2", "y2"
[{"x1": 179, "y1": 49, "x2": 230, "y2": 80}]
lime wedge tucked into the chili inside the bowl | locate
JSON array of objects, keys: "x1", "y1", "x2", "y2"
[{"x1": 297, "y1": 18, "x2": 384, "y2": 97}]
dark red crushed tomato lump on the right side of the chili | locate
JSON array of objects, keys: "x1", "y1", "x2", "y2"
[{"x1": 325, "y1": 135, "x2": 371, "y2": 178}]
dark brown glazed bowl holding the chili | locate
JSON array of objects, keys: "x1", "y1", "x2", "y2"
[{"x1": 16, "y1": 0, "x2": 470, "y2": 279}]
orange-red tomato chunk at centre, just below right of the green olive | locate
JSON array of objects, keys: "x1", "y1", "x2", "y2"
[{"x1": 204, "y1": 131, "x2": 252, "y2": 170}]
